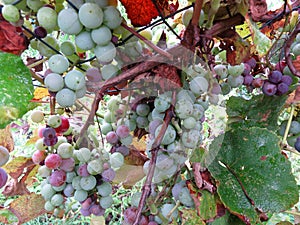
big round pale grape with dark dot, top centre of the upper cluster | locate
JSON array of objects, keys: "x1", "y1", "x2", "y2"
[{"x1": 78, "y1": 2, "x2": 103, "y2": 29}]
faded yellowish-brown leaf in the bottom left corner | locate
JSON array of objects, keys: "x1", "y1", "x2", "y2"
[{"x1": 9, "y1": 193, "x2": 46, "y2": 224}]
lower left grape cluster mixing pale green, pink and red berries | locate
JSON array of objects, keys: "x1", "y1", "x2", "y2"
[{"x1": 30, "y1": 110, "x2": 123, "y2": 216}]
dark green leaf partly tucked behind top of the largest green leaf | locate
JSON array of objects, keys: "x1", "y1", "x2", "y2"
[{"x1": 226, "y1": 95, "x2": 287, "y2": 131}]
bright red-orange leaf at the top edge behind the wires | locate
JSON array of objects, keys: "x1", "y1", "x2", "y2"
[{"x1": 120, "y1": 0, "x2": 168, "y2": 27}]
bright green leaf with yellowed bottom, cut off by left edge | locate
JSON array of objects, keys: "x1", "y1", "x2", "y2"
[{"x1": 0, "y1": 52, "x2": 34, "y2": 129}]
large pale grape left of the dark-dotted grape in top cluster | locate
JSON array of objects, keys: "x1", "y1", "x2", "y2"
[{"x1": 57, "y1": 8, "x2": 83, "y2": 34}]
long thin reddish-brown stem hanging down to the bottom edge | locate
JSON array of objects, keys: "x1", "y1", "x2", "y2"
[{"x1": 133, "y1": 91, "x2": 176, "y2": 225}]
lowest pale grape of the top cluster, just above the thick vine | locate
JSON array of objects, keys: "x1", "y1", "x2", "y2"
[{"x1": 94, "y1": 42, "x2": 117, "y2": 63}]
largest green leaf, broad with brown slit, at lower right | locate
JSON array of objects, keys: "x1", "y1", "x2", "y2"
[{"x1": 208, "y1": 127, "x2": 298, "y2": 224}]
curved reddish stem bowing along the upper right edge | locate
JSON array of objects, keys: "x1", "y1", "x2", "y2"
[{"x1": 284, "y1": 22, "x2": 300, "y2": 77}]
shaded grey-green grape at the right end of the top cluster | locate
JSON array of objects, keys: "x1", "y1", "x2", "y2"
[{"x1": 103, "y1": 6, "x2": 122, "y2": 30}]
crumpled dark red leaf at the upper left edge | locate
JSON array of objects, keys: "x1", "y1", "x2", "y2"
[{"x1": 0, "y1": 18, "x2": 28, "y2": 55}]
